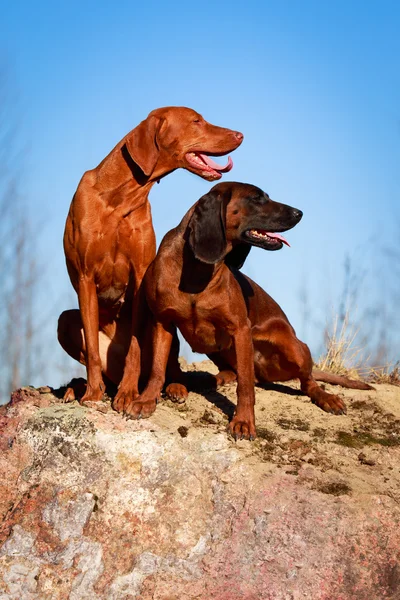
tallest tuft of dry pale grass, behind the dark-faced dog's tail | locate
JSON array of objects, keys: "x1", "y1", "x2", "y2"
[{"x1": 316, "y1": 313, "x2": 368, "y2": 378}]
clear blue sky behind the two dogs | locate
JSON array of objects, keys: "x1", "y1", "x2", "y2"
[{"x1": 0, "y1": 0, "x2": 400, "y2": 385}]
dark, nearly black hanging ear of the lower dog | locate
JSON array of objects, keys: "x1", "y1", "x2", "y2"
[{"x1": 188, "y1": 190, "x2": 228, "y2": 265}]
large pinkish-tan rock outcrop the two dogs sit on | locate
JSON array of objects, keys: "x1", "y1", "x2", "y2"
[{"x1": 0, "y1": 368, "x2": 400, "y2": 600}]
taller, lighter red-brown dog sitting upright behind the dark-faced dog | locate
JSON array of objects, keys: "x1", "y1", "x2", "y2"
[{"x1": 58, "y1": 107, "x2": 243, "y2": 401}]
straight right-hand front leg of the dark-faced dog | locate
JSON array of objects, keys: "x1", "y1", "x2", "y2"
[{"x1": 229, "y1": 321, "x2": 256, "y2": 440}]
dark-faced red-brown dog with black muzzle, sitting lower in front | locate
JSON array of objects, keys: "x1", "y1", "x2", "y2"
[{"x1": 114, "y1": 183, "x2": 371, "y2": 439}]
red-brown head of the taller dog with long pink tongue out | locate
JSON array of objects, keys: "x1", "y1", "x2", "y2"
[{"x1": 125, "y1": 106, "x2": 243, "y2": 181}]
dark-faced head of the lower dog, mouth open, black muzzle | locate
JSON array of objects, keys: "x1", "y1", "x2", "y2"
[{"x1": 188, "y1": 182, "x2": 303, "y2": 268}]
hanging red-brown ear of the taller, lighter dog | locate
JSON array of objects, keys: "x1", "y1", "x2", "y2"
[{"x1": 125, "y1": 115, "x2": 162, "y2": 177}]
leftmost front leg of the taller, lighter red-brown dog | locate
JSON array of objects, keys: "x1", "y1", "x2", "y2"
[{"x1": 78, "y1": 278, "x2": 105, "y2": 403}]
